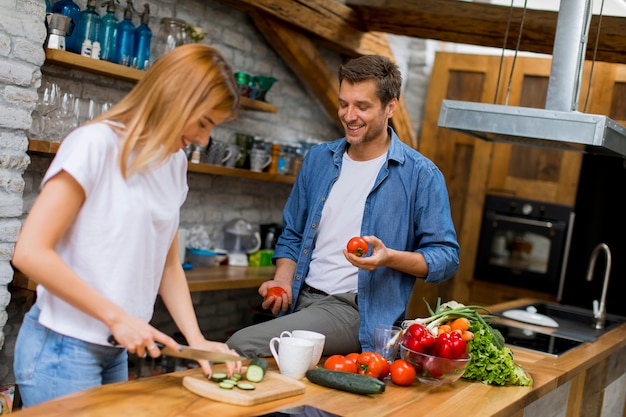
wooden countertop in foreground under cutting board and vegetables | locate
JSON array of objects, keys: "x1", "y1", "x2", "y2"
[{"x1": 9, "y1": 300, "x2": 626, "y2": 417}]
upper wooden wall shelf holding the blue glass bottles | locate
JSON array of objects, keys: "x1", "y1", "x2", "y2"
[{"x1": 46, "y1": 49, "x2": 278, "y2": 113}]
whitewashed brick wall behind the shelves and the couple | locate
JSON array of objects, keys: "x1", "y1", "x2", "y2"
[{"x1": 0, "y1": 0, "x2": 429, "y2": 386}]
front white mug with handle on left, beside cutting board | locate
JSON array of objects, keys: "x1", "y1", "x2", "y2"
[{"x1": 270, "y1": 337, "x2": 315, "y2": 379}]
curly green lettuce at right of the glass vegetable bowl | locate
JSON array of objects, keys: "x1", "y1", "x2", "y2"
[{"x1": 463, "y1": 323, "x2": 533, "y2": 386}]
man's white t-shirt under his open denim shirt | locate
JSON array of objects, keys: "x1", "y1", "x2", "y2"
[{"x1": 306, "y1": 152, "x2": 387, "y2": 294}]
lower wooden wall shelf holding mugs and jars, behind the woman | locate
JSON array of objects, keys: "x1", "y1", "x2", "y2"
[{"x1": 28, "y1": 139, "x2": 296, "y2": 184}]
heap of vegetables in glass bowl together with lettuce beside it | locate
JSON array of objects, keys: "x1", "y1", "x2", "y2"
[{"x1": 402, "y1": 299, "x2": 533, "y2": 386}]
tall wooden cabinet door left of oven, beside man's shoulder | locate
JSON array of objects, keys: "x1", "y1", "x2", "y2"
[{"x1": 407, "y1": 52, "x2": 500, "y2": 317}]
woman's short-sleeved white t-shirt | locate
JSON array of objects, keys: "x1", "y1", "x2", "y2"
[{"x1": 37, "y1": 123, "x2": 188, "y2": 345}]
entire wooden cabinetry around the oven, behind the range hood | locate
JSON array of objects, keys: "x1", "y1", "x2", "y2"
[{"x1": 408, "y1": 53, "x2": 582, "y2": 314}]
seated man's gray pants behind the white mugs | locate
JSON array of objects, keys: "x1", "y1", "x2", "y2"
[{"x1": 226, "y1": 291, "x2": 361, "y2": 358}]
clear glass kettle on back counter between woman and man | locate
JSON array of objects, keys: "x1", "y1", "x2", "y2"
[{"x1": 224, "y1": 219, "x2": 261, "y2": 266}]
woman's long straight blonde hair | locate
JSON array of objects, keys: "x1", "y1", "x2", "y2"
[{"x1": 93, "y1": 44, "x2": 239, "y2": 178}]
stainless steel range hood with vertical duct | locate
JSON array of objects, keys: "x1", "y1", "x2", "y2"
[{"x1": 438, "y1": 0, "x2": 626, "y2": 157}]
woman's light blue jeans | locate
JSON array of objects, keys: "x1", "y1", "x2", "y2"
[{"x1": 13, "y1": 304, "x2": 128, "y2": 407}]
